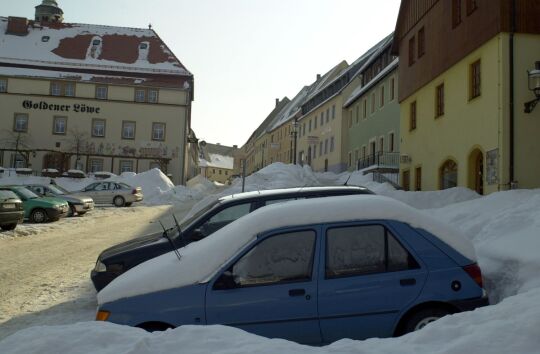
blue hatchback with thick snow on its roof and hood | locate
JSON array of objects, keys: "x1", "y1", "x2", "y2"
[{"x1": 97, "y1": 195, "x2": 488, "y2": 345}]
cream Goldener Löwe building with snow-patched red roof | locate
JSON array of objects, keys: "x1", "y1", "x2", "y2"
[{"x1": 0, "y1": 0, "x2": 193, "y2": 184}]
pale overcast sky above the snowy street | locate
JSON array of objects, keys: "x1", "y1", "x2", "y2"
[{"x1": 0, "y1": 0, "x2": 400, "y2": 146}]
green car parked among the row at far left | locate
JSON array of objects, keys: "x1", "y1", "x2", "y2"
[{"x1": 1, "y1": 186, "x2": 69, "y2": 223}]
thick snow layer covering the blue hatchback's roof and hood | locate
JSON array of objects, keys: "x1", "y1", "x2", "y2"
[{"x1": 98, "y1": 195, "x2": 476, "y2": 304}]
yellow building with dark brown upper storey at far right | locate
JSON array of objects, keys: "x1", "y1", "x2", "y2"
[{"x1": 394, "y1": 0, "x2": 540, "y2": 194}]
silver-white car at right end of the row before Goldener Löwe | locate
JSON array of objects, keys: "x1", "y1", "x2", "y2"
[{"x1": 77, "y1": 181, "x2": 143, "y2": 207}]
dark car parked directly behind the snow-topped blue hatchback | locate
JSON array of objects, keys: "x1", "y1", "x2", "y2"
[{"x1": 91, "y1": 186, "x2": 373, "y2": 291}]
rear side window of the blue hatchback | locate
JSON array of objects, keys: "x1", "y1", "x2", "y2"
[{"x1": 325, "y1": 225, "x2": 420, "y2": 279}]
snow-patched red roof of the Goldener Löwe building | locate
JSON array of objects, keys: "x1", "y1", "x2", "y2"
[{"x1": 0, "y1": 17, "x2": 191, "y2": 76}]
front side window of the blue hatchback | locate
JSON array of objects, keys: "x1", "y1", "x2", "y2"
[{"x1": 232, "y1": 230, "x2": 316, "y2": 286}]
